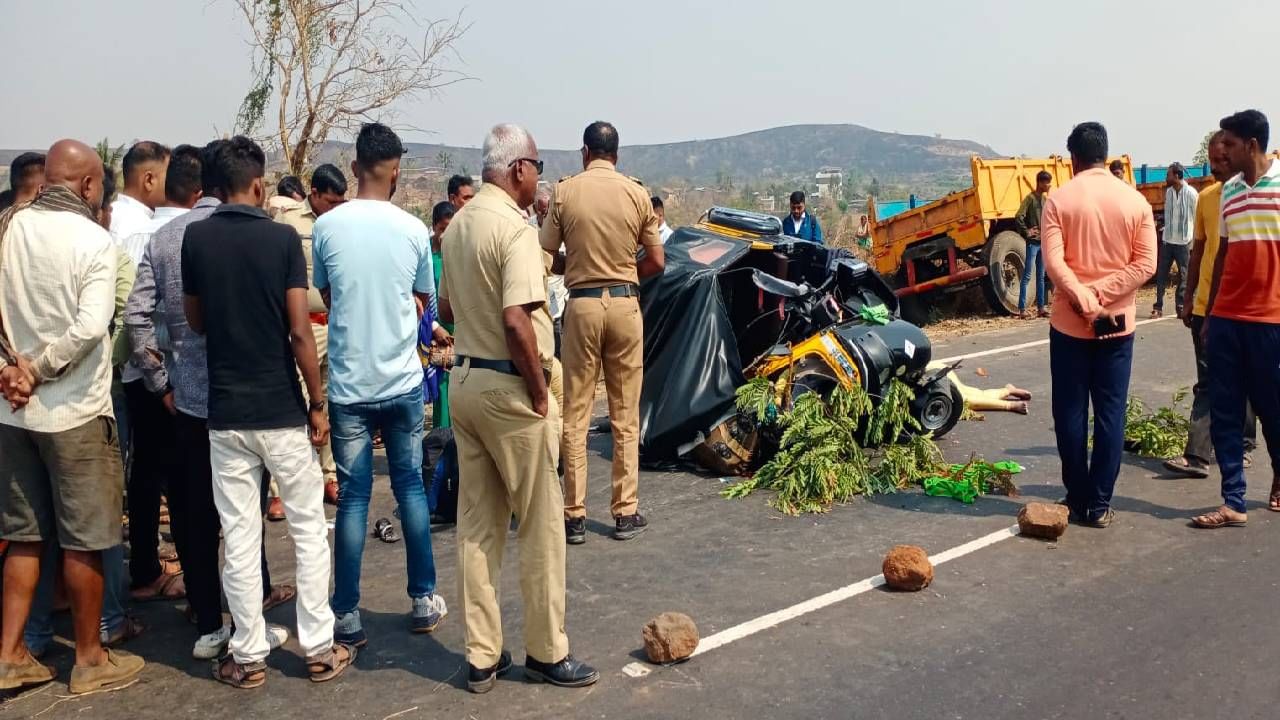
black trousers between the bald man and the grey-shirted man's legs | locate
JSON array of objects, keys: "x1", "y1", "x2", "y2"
[{"x1": 124, "y1": 380, "x2": 183, "y2": 588}]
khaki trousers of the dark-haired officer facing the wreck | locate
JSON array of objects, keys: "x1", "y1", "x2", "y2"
[{"x1": 561, "y1": 295, "x2": 644, "y2": 518}]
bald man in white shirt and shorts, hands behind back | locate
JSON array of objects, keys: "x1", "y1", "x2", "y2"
[{"x1": 0, "y1": 140, "x2": 143, "y2": 694}]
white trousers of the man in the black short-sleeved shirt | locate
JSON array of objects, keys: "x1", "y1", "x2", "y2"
[{"x1": 209, "y1": 428, "x2": 333, "y2": 662}]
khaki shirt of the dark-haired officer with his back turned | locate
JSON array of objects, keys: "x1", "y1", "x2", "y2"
[{"x1": 541, "y1": 160, "x2": 662, "y2": 290}]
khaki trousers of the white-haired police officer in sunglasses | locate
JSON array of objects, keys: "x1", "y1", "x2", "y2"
[{"x1": 449, "y1": 366, "x2": 568, "y2": 667}]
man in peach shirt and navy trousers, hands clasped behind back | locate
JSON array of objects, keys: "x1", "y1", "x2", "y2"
[{"x1": 1041, "y1": 123, "x2": 1156, "y2": 528}]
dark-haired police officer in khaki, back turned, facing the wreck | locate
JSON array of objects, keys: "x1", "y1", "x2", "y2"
[{"x1": 541, "y1": 122, "x2": 663, "y2": 544}]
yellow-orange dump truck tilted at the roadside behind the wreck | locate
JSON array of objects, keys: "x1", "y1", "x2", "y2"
[{"x1": 868, "y1": 155, "x2": 1134, "y2": 314}]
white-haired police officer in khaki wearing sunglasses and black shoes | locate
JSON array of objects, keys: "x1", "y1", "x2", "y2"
[{"x1": 440, "y1": 126, "x2": 600, "y2": 693}]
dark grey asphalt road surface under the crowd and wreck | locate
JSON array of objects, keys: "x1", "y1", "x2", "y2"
[{"x1": 0, "y1": 320, "x2": 1280, "y2": 720}]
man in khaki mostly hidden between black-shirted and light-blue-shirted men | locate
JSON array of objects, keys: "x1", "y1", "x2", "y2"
[{"x1": 271, "y1": 164, "x2": 347, "y2": 504}]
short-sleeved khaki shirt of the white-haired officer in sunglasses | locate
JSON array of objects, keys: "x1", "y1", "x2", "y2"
[{"x1": 439, "y1": 183, "x2": 556, "y2": 366}]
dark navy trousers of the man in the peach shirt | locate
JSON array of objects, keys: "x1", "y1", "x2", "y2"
[{"x1": 1048, "y1": 331, "x2": 1136, "y2": 520}]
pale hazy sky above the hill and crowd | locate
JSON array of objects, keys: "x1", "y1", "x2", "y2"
[{"x1": 0, "y1": 0, "x2": 1280, "y2": 163}]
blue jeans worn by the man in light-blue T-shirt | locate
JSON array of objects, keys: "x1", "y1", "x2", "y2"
[{"x1": 329, "y1": 388, "x2": 435, "y2": 615}]
